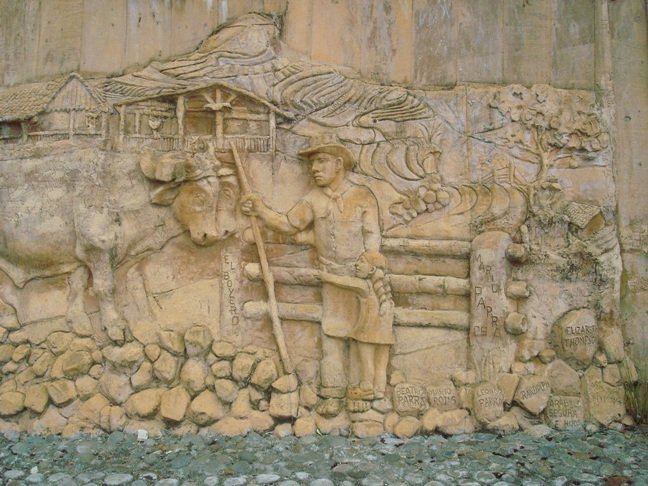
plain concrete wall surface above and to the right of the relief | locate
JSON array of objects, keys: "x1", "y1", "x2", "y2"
[{"x1": 0, "y1": 0, "x2": 648, "y2": 376}]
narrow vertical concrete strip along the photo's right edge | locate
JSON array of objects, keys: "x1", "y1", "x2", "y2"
[{"x1": 609, "y1": 0, "x2": 648, "y2": 380}]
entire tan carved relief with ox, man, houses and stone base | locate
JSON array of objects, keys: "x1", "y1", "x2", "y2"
[{"x1": 0, "y1": 14, "x2": 636, "y2": 437}]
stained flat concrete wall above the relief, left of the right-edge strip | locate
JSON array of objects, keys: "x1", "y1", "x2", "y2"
[{"x1": 0, "y1": 0, "x2": 612, "y2": 88}]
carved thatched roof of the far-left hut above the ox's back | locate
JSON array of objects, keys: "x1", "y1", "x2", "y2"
[{"x1": 0, "y1": 73, "x2": 110, "y2": 122}]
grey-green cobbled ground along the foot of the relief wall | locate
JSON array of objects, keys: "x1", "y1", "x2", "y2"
[{"x1": 0, "y1": 428, "x2": 648, "y2": 486}]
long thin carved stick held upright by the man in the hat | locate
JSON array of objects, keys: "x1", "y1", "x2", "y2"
[{"x1": 230, "y1": 141, "x2": 294, "y2": 374}]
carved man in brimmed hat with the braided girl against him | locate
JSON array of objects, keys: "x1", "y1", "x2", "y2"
[{"x1": 242, "y1": 136, "x2": 394, "y2": 400}]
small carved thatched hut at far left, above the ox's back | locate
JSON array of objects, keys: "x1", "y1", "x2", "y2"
[{"x1": 0, "y1": 73, "x2": 111, "y2": 142}]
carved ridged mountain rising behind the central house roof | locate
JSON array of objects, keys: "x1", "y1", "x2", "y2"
[{"x1": 101, "y1": 14, "x2": 433, "y2": 126}]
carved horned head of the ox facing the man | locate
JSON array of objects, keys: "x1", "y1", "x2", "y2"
[{"x1": 140, "y1": 151, "x2": 238, "y2": 246}]
